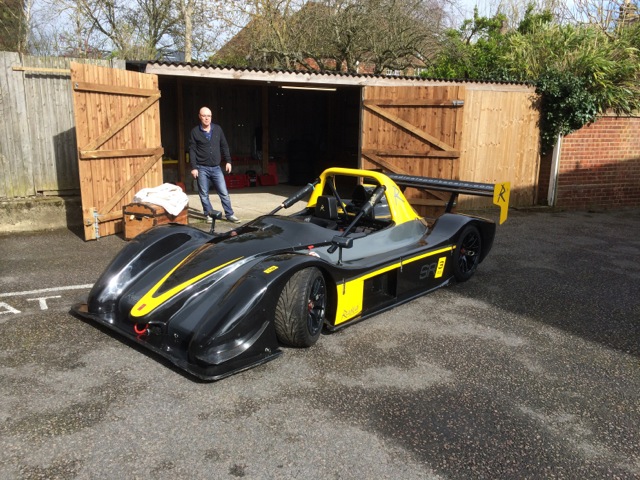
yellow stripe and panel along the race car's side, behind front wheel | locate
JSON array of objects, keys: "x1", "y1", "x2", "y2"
[{"x1": 334, "y1": 245, "x2": 456, "y2": 325}]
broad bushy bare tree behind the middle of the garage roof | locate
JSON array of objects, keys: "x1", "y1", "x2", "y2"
[{"x1": 219, "y1": 0, "x2": 444, "y2": 73}]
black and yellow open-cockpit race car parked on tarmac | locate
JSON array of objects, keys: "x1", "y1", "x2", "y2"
[{"x1": 72, "y1": 168, "x2": 509, "y2": 380}]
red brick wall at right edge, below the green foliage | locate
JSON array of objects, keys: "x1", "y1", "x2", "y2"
[{"x1": 552, "y1": 116, "x2": 640, "y2": 209}]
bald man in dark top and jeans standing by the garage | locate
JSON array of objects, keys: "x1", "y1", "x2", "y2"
[{"x1": 189, "y1": 107, "x2": 240, "y2": 223}]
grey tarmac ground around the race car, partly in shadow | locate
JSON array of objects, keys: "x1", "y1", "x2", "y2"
[{"x1": 0, "y1": 198, "x2": 640, "y2": 480}]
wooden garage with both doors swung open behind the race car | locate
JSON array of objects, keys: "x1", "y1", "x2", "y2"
[{"x1": 71, "y1": 63, "x2": 539, "y2": 239}]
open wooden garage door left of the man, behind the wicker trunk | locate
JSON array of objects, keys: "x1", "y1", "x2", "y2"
[{"x1": 71, "y1": 63, "x2": 164, "y2": 240}]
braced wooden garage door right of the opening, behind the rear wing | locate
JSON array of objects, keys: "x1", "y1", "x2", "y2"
[{"x1": 361, "y1": 86, "x2": 465, "y2": 215}]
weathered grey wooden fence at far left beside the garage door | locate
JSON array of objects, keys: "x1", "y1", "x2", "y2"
[{"x1": 0, "y1": 52, "x2": 125, "y2": 198}]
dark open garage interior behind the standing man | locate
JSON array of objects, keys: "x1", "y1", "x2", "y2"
[{"x1": 158, "y1": 75, "x2": 361, "y2": 191}]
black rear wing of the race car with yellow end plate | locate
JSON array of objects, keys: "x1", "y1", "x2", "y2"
[{"x1": 387, "y1": 173, "x2": 511, "y2": 224}]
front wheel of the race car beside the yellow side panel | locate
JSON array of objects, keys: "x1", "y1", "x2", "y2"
[{"x1": 275, "y1": 267, "x2": 327, "y2": 347}]
